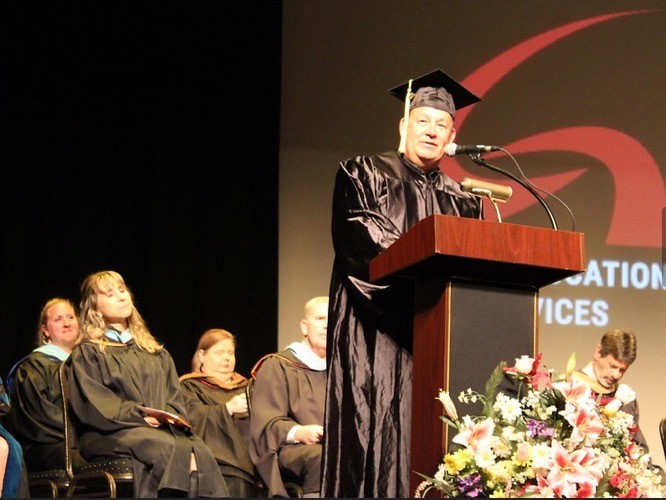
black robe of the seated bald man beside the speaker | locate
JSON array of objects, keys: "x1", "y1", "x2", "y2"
[{"x1": 250, "y1": 349, "x2": 326, "y2": 497}]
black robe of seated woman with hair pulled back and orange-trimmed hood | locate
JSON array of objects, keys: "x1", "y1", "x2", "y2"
[{"x1": 180, "y1": 373, "x2": 258, "y2": 498}]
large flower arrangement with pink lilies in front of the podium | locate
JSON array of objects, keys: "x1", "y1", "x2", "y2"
[{"x1": 415, "y1": 354, "x2": 666, "y2": 498}]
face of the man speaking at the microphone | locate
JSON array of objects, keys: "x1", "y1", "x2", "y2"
[{"x1": 400, "y1": 106, "x2": 456, "y2": 171}]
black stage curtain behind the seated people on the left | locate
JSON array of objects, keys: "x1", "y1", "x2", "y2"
[{"x1": 0, "y1": 0, "x2": 282, "y2": 378}]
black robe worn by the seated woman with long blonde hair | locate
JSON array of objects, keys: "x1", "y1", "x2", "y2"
[{"x1": 66, "y1": 341, "x2": 229, "y2": 497}]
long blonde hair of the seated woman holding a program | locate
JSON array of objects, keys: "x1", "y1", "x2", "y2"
[{"x1": 77, "y1": 271, "x2": 163, "y2": 353}]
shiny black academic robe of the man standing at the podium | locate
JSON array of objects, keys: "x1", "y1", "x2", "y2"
[{"x1": 322, "y1": 152, "x2": 481, "y2": 498}]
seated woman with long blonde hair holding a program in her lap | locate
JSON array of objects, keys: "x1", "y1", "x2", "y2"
[{"x1": 67, "y1": 271, "x2": 229, "y2": 498}]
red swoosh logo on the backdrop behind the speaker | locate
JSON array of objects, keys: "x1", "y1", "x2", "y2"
[{"x1": 446, "y1": 10, "x2": 666, "y2": 248}]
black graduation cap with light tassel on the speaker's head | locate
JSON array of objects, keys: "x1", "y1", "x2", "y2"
[{"x1": 389, "y1": 69, "x2": 481, "y2": 152}]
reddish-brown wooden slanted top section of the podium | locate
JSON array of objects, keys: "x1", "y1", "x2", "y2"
[{"x1": 370, "y1": 215, "x2": 585, "y2": 288}]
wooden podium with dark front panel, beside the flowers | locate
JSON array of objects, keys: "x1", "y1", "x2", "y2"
[{"x1": 370, "y1": 215, "x2": 585, "y2": 491}]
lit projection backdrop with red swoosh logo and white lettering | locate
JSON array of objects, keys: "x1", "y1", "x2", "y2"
[{"x1": 278, "y1": 0, "x2": 666, "y2": 473}]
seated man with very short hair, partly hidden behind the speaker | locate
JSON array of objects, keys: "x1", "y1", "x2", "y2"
[{"x1": 250, "y1": 297, "x2": 328, "y2": 498}]
